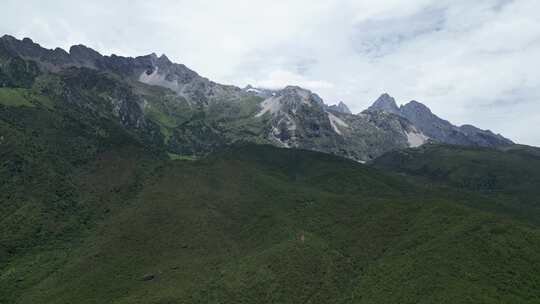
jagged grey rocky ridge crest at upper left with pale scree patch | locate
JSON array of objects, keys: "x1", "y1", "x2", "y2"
[{"x1": 0, "y1": 36, "x2": 247, "y2": 106}]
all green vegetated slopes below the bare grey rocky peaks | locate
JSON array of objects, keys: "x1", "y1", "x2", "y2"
[{"x1": 0, "y1": 56, "x2": 540, "y2": 303}]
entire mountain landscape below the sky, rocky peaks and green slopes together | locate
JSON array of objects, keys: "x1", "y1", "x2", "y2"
[{"x1": 0, "y1": 36, "x2": 540, "y2": 304}]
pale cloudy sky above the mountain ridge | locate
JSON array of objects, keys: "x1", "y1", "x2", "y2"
[{"x1": 0, "y1": 0, "x2": 540, "y2": 146}]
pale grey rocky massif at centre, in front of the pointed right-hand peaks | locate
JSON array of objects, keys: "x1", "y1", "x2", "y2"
[{"x1": 256, "y1": 86, "x2": 423, "y2": 161}]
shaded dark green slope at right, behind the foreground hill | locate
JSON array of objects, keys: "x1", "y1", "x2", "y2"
[{"x1": 374, "y1": 144, "x2": 540, "y2": 224}]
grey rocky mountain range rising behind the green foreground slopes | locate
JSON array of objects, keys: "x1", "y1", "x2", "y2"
[{"x1": 0, "y1": 35, "x2": 512, "y2": 162}]
